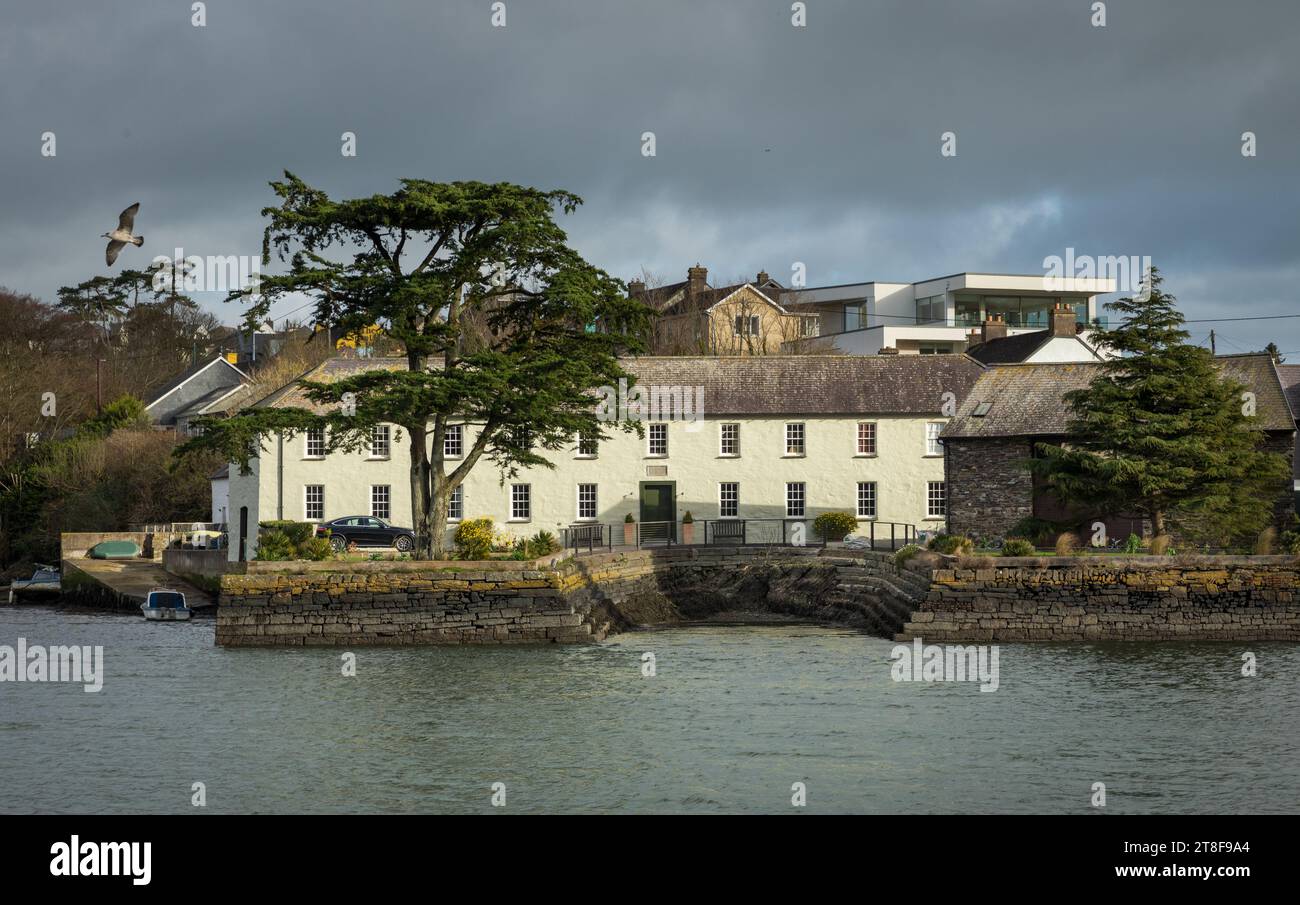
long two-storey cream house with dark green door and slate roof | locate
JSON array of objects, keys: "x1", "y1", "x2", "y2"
[{"x1": 229, "y1": 355, "x2": 983, "y2": 559}]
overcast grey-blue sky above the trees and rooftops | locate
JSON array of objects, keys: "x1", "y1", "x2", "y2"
[{"x1": 0, "y1": 0, "x2": 1300, "y2": 353}]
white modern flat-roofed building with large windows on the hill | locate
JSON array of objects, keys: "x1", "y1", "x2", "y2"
[{"x1": 781, "y1": 273, "x2": 1117, "y2": 355}]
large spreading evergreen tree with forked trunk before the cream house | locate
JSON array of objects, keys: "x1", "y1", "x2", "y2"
[{"x1": 185, "y1": 172, "x2": 650, "y2": 558}]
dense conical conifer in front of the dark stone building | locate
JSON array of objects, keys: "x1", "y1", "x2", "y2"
[{"x1": 1032, "y1": 268, "x2": 1290, "y2": 540}]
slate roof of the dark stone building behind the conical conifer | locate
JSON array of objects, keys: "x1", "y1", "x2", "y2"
[{"x1": 943, "y1": 354, "x2": 1295, "y2": 439}]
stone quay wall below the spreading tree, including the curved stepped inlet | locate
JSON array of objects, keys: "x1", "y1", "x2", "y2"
[{"x1": 217, "y1": 546, "x2": 928, "y2": 646}]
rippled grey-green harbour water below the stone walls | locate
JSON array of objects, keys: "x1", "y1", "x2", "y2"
[{"x1": 0, "y1": 607, "x2": 1300, "y2": 814}]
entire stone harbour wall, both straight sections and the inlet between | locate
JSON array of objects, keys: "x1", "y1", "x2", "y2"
[{"x1": 216, "y1": 546, "x2": 1300, "y2": 646}]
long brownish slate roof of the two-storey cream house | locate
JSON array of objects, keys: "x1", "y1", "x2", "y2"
[{"x1": 257, "y1": 355, "x2": 983, "y2": 417}]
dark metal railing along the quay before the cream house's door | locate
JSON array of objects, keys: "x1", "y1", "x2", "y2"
[{"x1": 560, "y1": 518, "x2": 919, "y2": 553}]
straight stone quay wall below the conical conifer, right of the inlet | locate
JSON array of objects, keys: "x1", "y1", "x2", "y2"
[{"x1": 898, "y1": 557, "x2": 1300, "y2": 642}]
